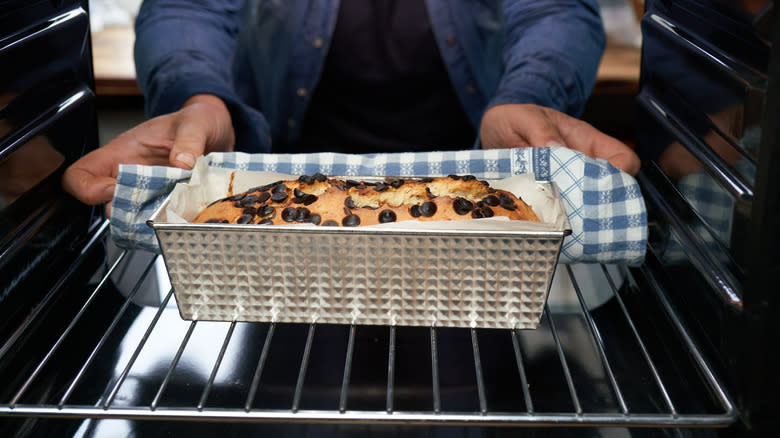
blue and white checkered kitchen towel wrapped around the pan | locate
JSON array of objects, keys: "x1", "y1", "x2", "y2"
[{"x1": 111, "y1": 147, "x2": 647, "y2": 265}]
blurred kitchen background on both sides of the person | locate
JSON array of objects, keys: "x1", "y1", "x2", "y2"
[{"x1": 90, "y1": 0, "x2": 644, "y2": 145}]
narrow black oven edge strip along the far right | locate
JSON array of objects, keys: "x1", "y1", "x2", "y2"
[{"x1": 734, "y1": 10, "x2": 780, "y2": 436}]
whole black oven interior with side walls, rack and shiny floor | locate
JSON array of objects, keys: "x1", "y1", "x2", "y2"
[{"x1": 0, "y1": 0, "x2": 780, "y2": 437}]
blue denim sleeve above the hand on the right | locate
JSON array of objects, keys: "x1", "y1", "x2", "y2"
[{"x1": 488, "y1": 0, "x2": 606, "y2": 117}]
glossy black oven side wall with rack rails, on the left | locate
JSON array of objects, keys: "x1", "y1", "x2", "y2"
[{"x1": 0, "y1": 0, "x2": 102, "y2": 346}]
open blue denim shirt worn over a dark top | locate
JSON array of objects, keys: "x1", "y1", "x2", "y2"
[{"x1": 135, "y1": 0, "x2": 606, "y2": 152}]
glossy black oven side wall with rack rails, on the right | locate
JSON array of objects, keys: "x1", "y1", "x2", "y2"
[{"x1": 637, "y1": 0, "x2": 780, "y2": 436}]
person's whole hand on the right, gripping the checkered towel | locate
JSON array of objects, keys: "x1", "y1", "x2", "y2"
[{"x1": 480, "y1": 104, "x2": 640, "y2": 175}]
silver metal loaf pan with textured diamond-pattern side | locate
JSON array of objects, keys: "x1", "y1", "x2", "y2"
[{"x1": 149, "y1": 179, "x2": 570, "y2": 329}]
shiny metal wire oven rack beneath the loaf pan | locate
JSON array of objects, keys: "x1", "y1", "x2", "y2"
[{"x1": 0, "y1": 227, "x2": 737, "y2": 427}]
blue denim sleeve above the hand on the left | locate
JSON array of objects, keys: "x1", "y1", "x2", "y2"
[{"x1": 135, "y1": 0, "x2": 270, "y2": 152}]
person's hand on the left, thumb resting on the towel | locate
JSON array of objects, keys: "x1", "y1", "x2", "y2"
[{"x1": 62, "y1": 94, "x2": 235, "y2": 211}]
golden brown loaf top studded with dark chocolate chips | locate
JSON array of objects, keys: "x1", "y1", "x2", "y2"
[{"x1": 193, "y1": 174, "x2": 539, "y2": 226}]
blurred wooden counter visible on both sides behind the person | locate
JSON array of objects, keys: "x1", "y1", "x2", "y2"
[{"x1": 92, "y1": 27, "x2": 639, "y2": 97}]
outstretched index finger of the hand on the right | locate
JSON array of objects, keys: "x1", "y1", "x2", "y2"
[{"x1": 548, "y1": 110, "x2": 641, "y2": 175}]
